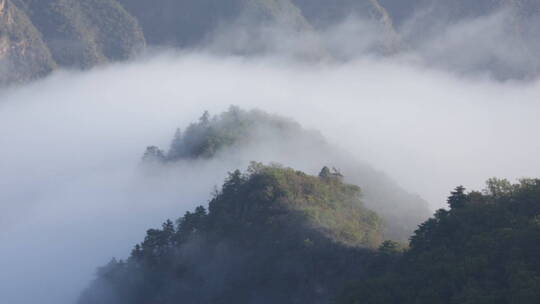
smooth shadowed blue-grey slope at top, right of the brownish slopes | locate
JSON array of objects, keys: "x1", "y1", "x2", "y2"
[{"x1": 120, "y1": 0, "x2": 309, "y2": 47}]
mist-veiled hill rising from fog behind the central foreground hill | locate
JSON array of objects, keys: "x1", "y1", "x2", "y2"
[{"x1": 144, "y1": 107, "x2": 431, "y2": 241}]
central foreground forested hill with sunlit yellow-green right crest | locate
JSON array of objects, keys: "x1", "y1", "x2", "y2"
[{"x1": 79, "y1": 163, "x2": 382, "y2": 304}]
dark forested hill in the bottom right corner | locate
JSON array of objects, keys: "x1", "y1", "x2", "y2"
[{"x1": 340, "y1": 179, "x2": 540, "y2": 304}]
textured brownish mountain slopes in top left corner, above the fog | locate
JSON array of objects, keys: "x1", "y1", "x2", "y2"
[{"x1": 0, "y1": 0, "x2": 145, "y2": 84}]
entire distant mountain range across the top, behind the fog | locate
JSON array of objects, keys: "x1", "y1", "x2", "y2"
[{"x1": 4, "y1": 0, "x2": 540, "y2": 83}]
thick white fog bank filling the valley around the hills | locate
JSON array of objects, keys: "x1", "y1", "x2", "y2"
[{"x1": 0, "y1": 8, "x2": 540, "y2": 304}]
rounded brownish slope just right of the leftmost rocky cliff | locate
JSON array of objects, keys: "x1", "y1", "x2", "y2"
[{"x1": 18, "y1": 0, "x2": 144, "y2": 68}]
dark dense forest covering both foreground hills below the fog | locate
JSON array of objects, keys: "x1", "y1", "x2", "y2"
[{"x1": 79, "y1": 163, "x2": 540, "y2": 304}]
